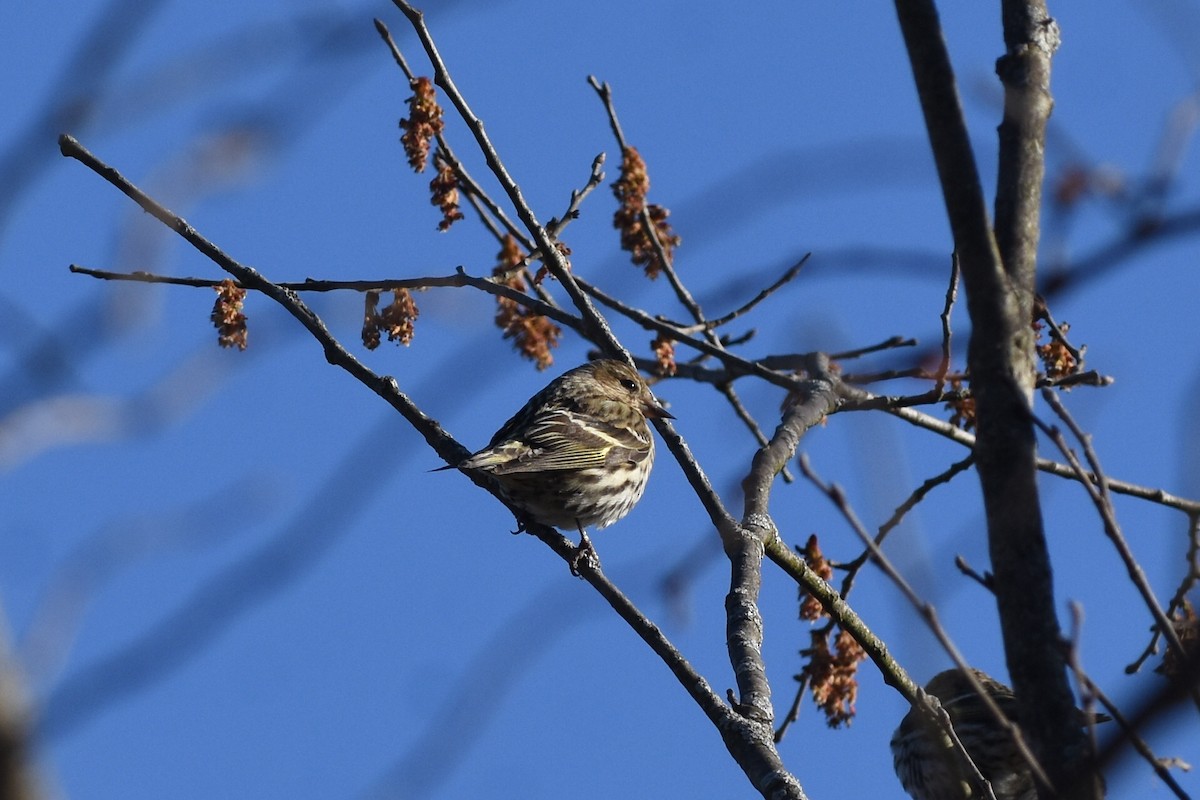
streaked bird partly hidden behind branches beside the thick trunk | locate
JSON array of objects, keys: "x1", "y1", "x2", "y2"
[{"x1": 892, "y1": 669, "x2": 1108, "y2": 800}]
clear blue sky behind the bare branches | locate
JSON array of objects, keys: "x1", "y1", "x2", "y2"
[{"x1": 0, "y1": 0, "x2": 1200, "y2": 799}]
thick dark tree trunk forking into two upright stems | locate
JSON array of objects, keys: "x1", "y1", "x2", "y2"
[{"x1": 895, "y1": 0, "x2": 1099, "y2": 800}]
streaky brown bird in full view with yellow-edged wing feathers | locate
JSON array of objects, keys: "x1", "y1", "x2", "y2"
[{"x1": 457, "y1": 360, "x2": 673, "y2": 569}]
